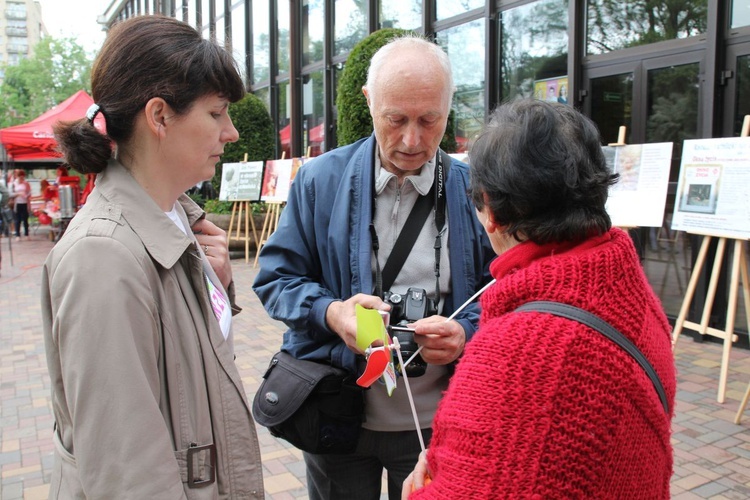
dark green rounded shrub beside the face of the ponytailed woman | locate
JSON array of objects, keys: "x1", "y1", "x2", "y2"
[{"x1": 213, "y1": 94, "x2": 277, "y2": 195}]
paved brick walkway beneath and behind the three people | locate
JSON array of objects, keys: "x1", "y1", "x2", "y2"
[{"x1": 0, "y1": 229, "x2": 750, "y2": 500}]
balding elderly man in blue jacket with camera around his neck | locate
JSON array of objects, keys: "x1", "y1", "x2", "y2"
[{"x1": 253, "y1": 33, "x2": 492, "y2": 500}]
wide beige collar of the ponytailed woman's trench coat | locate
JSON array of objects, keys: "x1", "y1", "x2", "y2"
[{"x1": 96, "y1": 160, "x2": 203, "y2": 268}]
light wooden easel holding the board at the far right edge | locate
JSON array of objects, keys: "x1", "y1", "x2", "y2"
[{"x1": 672, "y1": 115, "x2": 750, "y2": 404}]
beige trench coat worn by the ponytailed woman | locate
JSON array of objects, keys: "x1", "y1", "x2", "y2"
[{"x1": 42, "y1": 162, "x2": 264, "y2": 500}]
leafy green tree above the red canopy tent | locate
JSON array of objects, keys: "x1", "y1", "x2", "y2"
[{"x1": 0, "y1": 37, "x2": 93, "y2": 127}]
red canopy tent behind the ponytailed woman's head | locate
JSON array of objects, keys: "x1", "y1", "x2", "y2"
[{"x1": 0, "y1": 90, "x2": 105, "y2": 161}]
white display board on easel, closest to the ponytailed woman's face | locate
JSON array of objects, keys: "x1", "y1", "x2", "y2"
[{"x1": 219, "y1": 158, "x2": 264, "y2": 262}]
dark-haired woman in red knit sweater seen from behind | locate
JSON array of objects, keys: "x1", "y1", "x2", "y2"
[{"x1": 404, "y1": 100, "x2": 676, "y2": 500}]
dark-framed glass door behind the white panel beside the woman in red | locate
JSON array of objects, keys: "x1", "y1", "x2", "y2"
[{"x1": 582, "y1": 51, "x2": 703, "y2": 316}]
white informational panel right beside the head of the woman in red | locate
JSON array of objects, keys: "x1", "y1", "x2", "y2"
[{"x1": 602, "y1": 142, "x2": 673, "y2": 227}]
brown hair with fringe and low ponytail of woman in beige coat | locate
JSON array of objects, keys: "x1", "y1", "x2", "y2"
[{"x1": 54, "y1": 15, "x2": 245, "y2": 174}]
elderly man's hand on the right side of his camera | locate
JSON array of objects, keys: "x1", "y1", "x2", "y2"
[{"x1": 409, "y1": 316, "x2": 466, "y2": 365}]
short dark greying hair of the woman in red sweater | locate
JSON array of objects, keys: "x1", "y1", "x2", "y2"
[{"x1": 469, "y1": 99, "x2": 617, "y2": 245}]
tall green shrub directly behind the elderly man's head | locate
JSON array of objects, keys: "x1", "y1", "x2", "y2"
[{"x1": 336, "y1": 28, "x2": 458, "y2": 153}]
